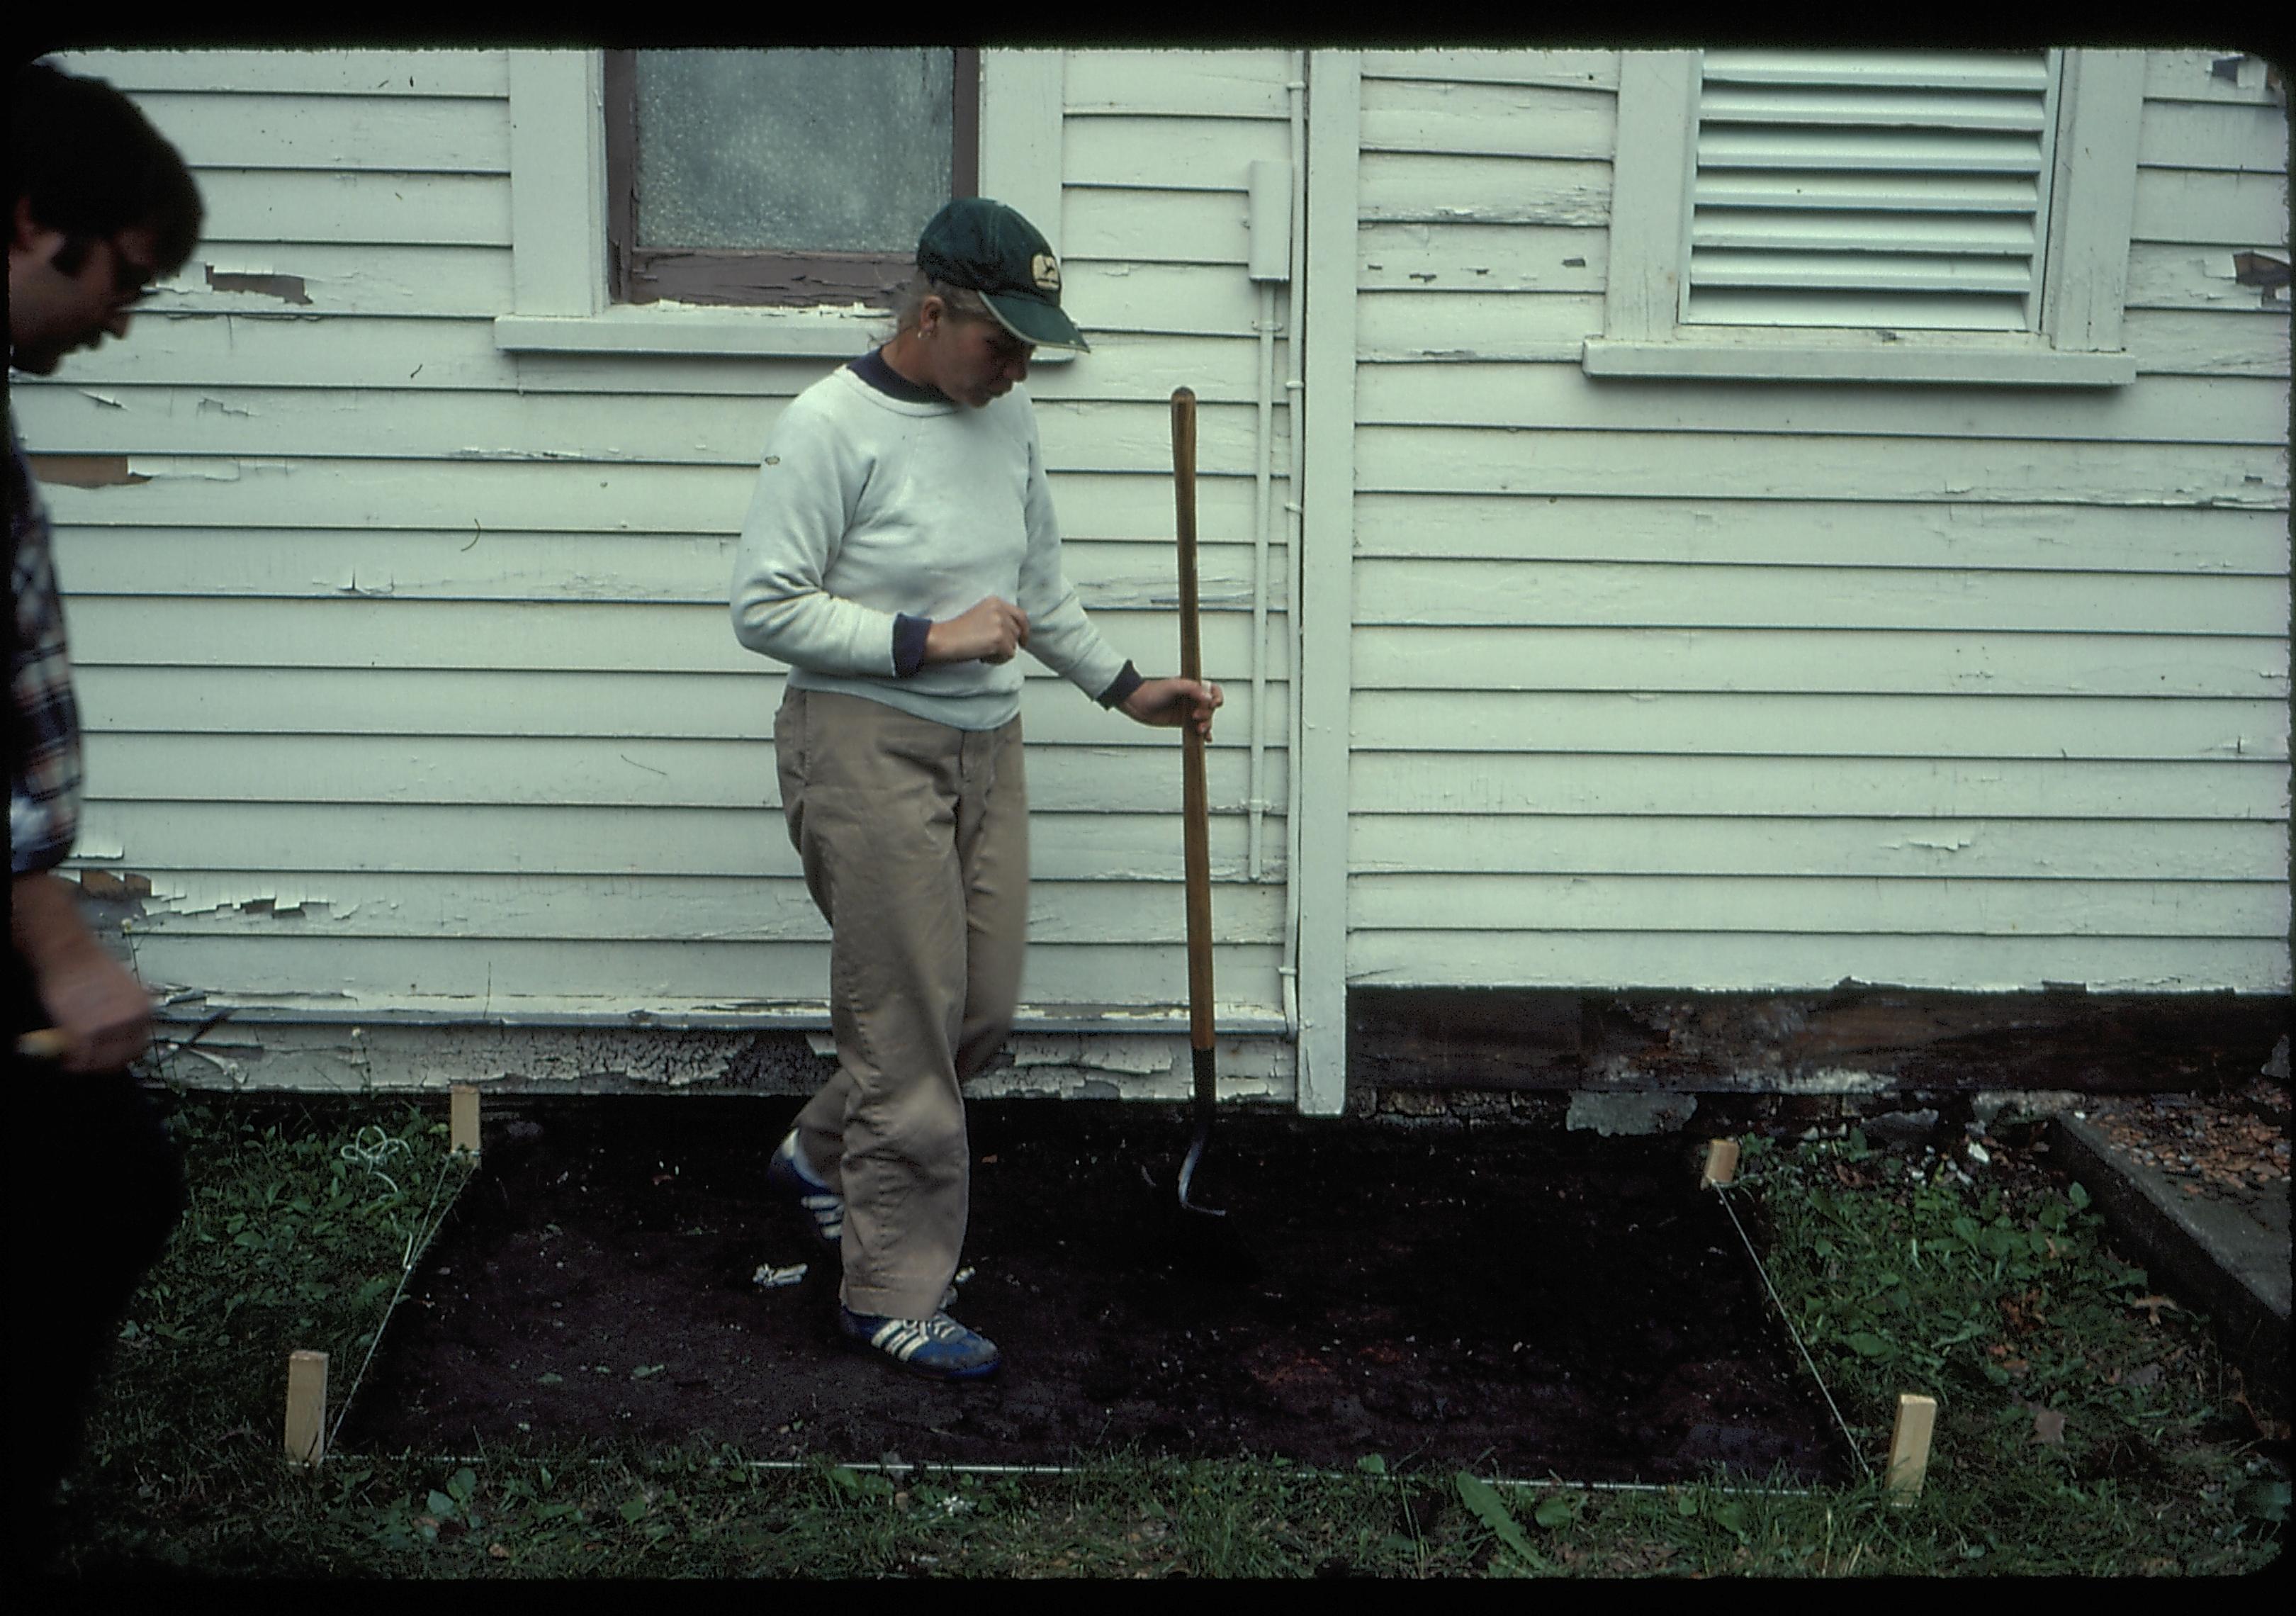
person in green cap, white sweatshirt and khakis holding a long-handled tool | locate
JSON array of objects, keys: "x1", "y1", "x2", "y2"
[{"x1": 733, "y1": 198, "x2": 1222, "y2": 1379}]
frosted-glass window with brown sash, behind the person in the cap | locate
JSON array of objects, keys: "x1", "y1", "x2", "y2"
[{"x1": 604, "y1": 50, "x2": 980, "y2": 308}]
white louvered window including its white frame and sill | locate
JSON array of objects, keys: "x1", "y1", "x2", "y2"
[{"x1": 1585, "y1": 50, "x2": 2142, "y2": 386}]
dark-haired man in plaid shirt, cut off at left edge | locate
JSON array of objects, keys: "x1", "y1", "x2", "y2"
[{"x1": 7, "y1": 62, "x2": 202, "y2": 1572}]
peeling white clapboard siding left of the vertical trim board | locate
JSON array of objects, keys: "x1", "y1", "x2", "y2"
[{"x1": 16, "y1": 50, "x2": 1293, "y2": 1037}]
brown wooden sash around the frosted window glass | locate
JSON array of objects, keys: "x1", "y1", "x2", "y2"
[{"x1": 606, "y1": 50, "x2": 980, "y2": 308}]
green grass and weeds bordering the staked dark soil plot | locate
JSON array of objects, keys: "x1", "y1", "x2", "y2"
[{"x1": 31, "y1": 1097, "x2": 2287, "y2": 1579}]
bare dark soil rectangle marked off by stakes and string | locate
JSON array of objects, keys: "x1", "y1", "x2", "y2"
[{"x1": 342, "y1": 1097, "x2": 1848, "y2": 1481}]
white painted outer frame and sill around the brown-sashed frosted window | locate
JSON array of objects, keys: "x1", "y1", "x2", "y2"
[{"x1": 494, "y1": 50, "x2": 1070, "y2": 363}]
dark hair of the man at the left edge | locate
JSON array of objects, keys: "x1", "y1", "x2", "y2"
[{"x1": 7, "y1": 62, "x2": 204, "y2": 276}]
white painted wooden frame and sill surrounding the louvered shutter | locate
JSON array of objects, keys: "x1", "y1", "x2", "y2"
[{"x1": 1582, "y1": 50, "x2": 2144, "y2": 388}]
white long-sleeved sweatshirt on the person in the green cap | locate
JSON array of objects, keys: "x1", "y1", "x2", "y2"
[{"x1": 733, "y1": 367, "x2": 1125, "y2": 730}]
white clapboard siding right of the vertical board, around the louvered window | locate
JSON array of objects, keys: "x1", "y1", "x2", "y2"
[{"x1": 1341, "y1": 50, "x2": 2289, "y2": 992}]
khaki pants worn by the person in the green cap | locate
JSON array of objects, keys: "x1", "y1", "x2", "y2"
[{"x1": 774, "y1": 691, "x2": 1029, "y2": 1318}]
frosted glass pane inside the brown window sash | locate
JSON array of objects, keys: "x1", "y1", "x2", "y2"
[{"x1": 636, "y1": 50, "x2": 955, "y2": 252}]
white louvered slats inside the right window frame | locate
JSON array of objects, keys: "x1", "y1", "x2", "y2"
[{"x1": 1681, "y1": 50, "x2": 2057, "y2": 330}]
